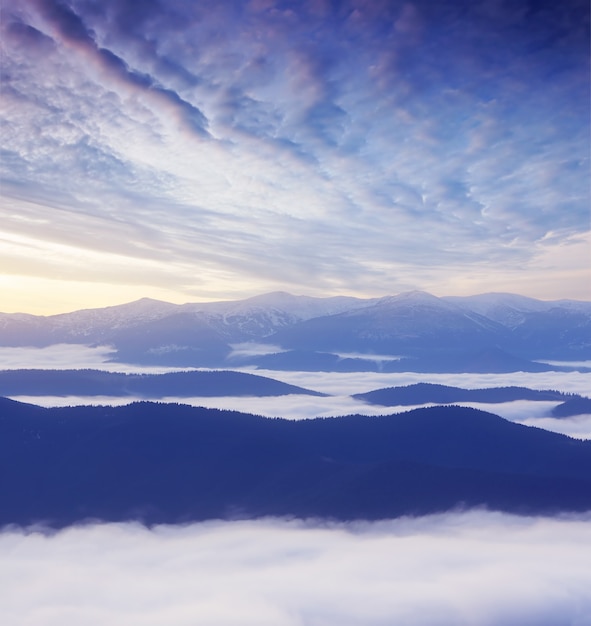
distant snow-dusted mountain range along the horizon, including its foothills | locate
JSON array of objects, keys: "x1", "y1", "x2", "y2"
[{"x1": 0, "y1": 291, "x2": 591, "y2": 372}]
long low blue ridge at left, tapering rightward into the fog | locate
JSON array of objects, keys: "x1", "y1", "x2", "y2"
[{"x1": 0, "y1": 369, "x2": 324, "y2": 398}]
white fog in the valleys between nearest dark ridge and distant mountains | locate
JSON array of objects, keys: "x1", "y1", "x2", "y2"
[{"x1": 0, "y1": 344, "x2": 591, "y2": 439}]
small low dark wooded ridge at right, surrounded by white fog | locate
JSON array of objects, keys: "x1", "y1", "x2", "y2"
[{"x1": 353, "y1": 383, "x2": 576, "y2": 406}]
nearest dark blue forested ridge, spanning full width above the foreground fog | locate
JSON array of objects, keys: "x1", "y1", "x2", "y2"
[{"x1": 0, "y1": 399, "x2": 591, "y2": 526}]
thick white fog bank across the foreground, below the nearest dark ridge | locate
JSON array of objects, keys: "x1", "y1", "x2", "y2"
[{"x1": 0, "y1": 511, "x2": 591, "y2": 626}]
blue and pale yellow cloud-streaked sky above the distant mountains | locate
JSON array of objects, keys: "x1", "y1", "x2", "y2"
[{"x1": 0, "y1": 0, "x2": 591, "y2": 314}]
